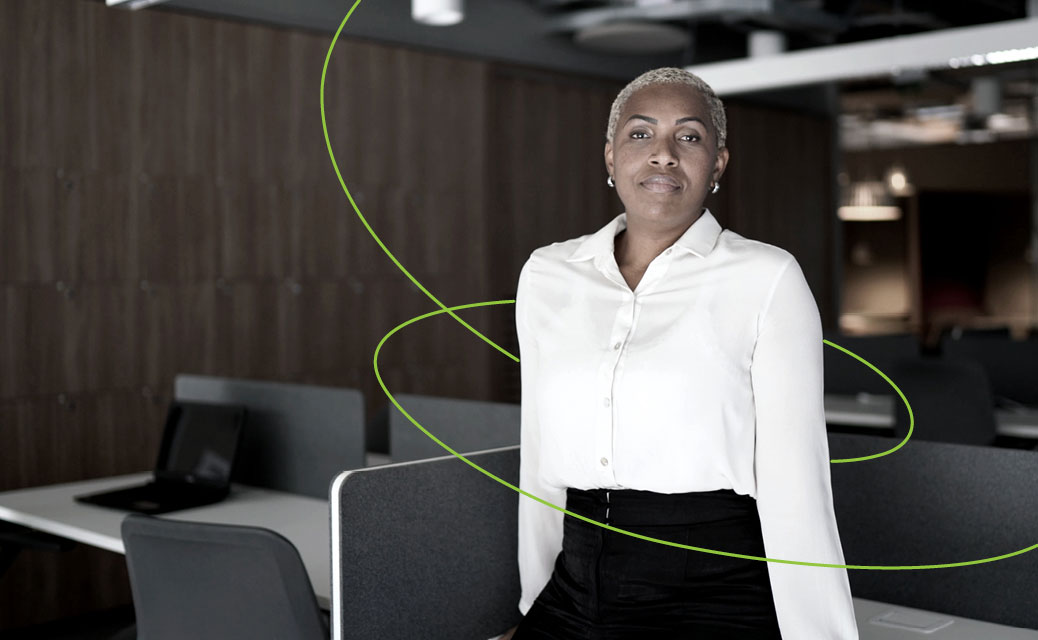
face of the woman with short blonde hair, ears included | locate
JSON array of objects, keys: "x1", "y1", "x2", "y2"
[{"x1": 605, "y1": 84, "x2": 728, "y2": 225}]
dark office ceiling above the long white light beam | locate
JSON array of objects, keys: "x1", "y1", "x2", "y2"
[{"x1": 148, "y1": 0, "x2": 1038, "y2": 79}]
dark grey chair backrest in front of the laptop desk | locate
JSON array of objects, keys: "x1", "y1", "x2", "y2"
[{"x1": 122, "y1": 514, "x2": 328, "y2": 640}]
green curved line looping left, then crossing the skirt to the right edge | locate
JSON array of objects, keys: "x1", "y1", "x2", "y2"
[{"x1": 373, "y1": 300, "x2": 1038, "y2": 572}]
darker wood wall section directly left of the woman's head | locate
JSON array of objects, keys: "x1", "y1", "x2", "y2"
[{"x1": 486, "y1": 67, "x2": 623, "y2": 402}]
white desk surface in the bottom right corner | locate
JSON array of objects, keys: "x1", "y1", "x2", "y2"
[{"x1": 854, "y1": 597, "x2": 1038, "y2": 640}]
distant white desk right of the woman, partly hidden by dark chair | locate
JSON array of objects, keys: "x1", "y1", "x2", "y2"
[{"x1": 824, "y1": 393, "x2": 1038, "y2": 440}]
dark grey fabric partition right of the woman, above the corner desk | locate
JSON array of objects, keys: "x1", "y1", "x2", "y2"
[{"x1": 829, "y1": 434, "x2": 1038, "y2": 629}]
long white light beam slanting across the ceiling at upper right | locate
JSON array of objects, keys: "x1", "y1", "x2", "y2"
[{"x1": 685, "y1": 18, "x2": 1038, "y2": 95}]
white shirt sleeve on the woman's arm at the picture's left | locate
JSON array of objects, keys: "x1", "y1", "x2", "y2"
[{"x1": 516, "y1": 257, "x2": 566, "y2": 615}]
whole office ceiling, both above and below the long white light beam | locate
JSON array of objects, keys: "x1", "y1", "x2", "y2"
[{"x1": 119, "y1": 0, "x2": 1038, "y2": 148}]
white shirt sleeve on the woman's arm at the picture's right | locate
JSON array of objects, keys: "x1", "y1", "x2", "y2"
[{"x1": 750, "y1": 258, "x2": 857, "y2": 640}]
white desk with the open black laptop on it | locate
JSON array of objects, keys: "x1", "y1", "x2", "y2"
[{"x1": 0, "y1": 473, "x2": 331, "y2": 609}]
